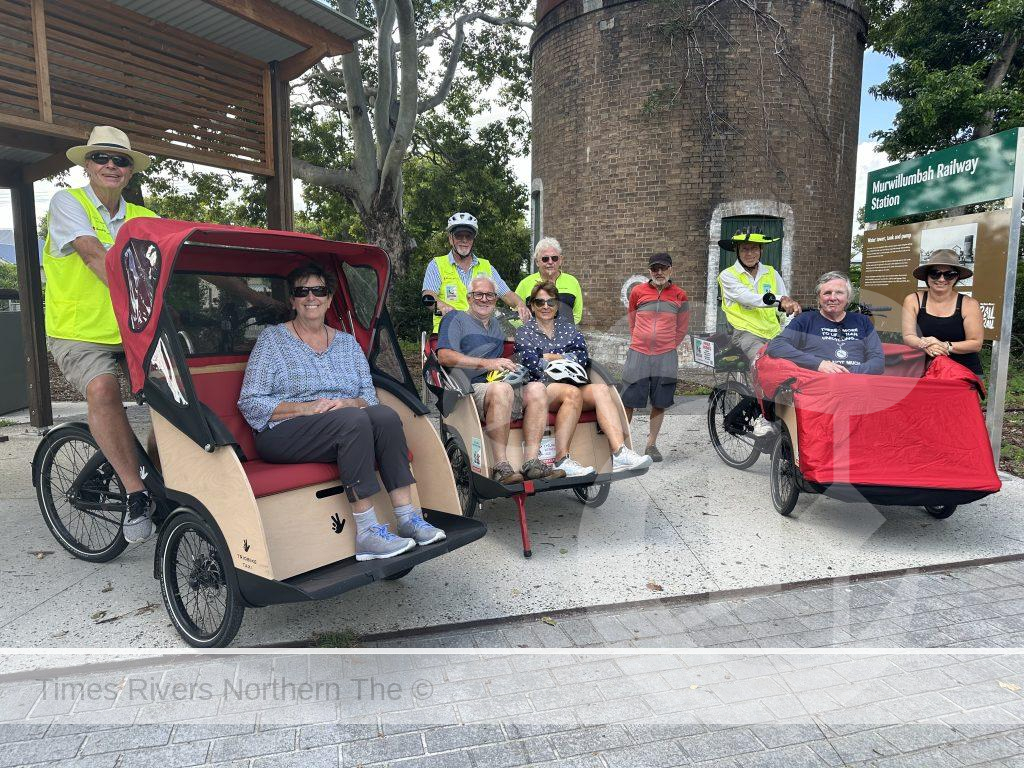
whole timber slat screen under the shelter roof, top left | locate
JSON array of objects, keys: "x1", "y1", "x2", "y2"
[{"x1": 0, "y1": 0, "x2": 273, "y2": 175}]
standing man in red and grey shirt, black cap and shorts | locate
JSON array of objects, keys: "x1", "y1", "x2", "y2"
[{"x1": 623, "y1": 253, "x2": 690, "y2": 462}]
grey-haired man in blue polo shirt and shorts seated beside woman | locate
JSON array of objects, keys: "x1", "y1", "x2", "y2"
[{"x1": 437, "y1": 274, "x2": 565, "y2": 484}]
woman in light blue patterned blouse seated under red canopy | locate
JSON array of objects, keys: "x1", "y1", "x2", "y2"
[{"x1": 239, "y1": 264, "x2": 444, "y2": 560}]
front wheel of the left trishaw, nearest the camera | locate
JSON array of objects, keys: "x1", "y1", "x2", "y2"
[{"x1": 157, "y1": 510, "x2": 246, "y2": 648}]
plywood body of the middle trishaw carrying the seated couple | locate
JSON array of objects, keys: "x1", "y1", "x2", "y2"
[{"x1": 421, "y1": 319, "x2": 647, "y2": 557}]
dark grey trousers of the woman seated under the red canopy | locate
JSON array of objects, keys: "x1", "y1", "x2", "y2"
[{"x1": 256, "y1": 406, "x2": 416, "y2": 502}]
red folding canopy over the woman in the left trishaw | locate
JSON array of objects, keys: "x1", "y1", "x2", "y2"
[{"x1": 106, "y1": 218, "x2": 390, "y2": 393}]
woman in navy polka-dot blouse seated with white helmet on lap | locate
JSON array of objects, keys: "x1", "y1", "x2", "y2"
[{"x1": 515, "y1": 281, "x2": 650, "y2": 477}]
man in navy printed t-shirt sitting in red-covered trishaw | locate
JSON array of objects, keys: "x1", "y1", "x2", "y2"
[{"x1": 768, "y1": 272, "x2": 886, "y2": 374}]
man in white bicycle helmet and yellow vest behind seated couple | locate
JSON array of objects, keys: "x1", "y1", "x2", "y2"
[{"x1": 421, "y1": 212, "x2": 529, "y2": 333}]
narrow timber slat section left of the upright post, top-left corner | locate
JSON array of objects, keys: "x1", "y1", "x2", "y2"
[{"x1": 0, "y1": 0, "x2": 39, "y2": 120}]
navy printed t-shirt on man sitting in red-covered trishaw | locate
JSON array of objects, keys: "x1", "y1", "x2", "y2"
[{"x1": 768, "y1": 312, "x2": 886, "y2": 374}]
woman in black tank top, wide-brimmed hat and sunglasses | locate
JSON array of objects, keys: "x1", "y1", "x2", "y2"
[{"x1": 903, "y1": 249, "x2": 984, "y2": 376}]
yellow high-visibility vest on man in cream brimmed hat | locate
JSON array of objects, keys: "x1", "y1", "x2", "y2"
[{"x1": 43, "y1": 188, "x2": 157, "y2": 344}]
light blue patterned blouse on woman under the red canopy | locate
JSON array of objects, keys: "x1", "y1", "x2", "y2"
[{"x1": 239, "y1": 324, "x2": 377, "y2": 432}]
